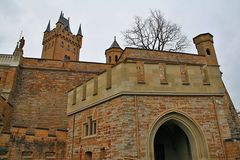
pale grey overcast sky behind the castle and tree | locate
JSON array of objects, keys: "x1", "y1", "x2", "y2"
[{"x1": 0, "y1": 0, "x2": 240, "y2": 110}]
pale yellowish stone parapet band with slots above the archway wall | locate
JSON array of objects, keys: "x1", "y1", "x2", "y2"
[{"x1": 67, "y1": 61, "x2": 224, "y2": 115}]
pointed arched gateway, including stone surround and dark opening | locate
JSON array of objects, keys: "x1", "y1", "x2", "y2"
[{"x1": 147, "y1": 111, "x2": 208, "y2": 160}]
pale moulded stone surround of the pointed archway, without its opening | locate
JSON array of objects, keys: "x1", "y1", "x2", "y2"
[{"x1": 147, "y1": 111, "x2": 209, "y2": 160}]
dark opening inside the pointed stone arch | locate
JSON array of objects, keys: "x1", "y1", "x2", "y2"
[{"x1": 154, "y1": 121, "x2": 192, "y2": 160}]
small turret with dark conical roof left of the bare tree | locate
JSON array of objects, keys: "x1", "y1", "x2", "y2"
[{"x1": 105, "y1": 36, "x2": 123, "y2": 64}]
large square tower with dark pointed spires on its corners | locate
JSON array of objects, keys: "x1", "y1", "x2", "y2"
[{"x1": 42, "y1": 12, "x2": 83, "y2": 61}]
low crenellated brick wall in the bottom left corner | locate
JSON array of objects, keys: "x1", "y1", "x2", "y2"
[{"x1": 0, "y1": 126, "x2": 67, "y2": 159}]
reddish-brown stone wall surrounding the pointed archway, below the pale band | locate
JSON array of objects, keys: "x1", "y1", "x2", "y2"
[{"x1": 67, "y1": 95, "x2": 230, "y2": 160}]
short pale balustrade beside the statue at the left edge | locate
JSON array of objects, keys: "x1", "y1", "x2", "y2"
[{"x1": 0, "y1": 54, "x2": 20, "y2": 66}]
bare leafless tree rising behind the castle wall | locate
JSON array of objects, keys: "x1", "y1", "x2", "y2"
[{"x1": 123, "y1": 10, "x2": 189, "y2": 51}]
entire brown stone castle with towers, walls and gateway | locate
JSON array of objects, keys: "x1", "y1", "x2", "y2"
[{"x1": 0, "y1": 13, "x2": 240, "y2": 160}]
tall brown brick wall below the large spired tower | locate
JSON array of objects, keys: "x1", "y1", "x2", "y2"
[{"x1": 11, "y1": 58, "x2": 109, "y2": 130}]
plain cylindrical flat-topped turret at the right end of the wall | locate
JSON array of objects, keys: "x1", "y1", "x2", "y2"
[{"x1": 193, "y1": 33, "x2": 218, "y2": 65}]
